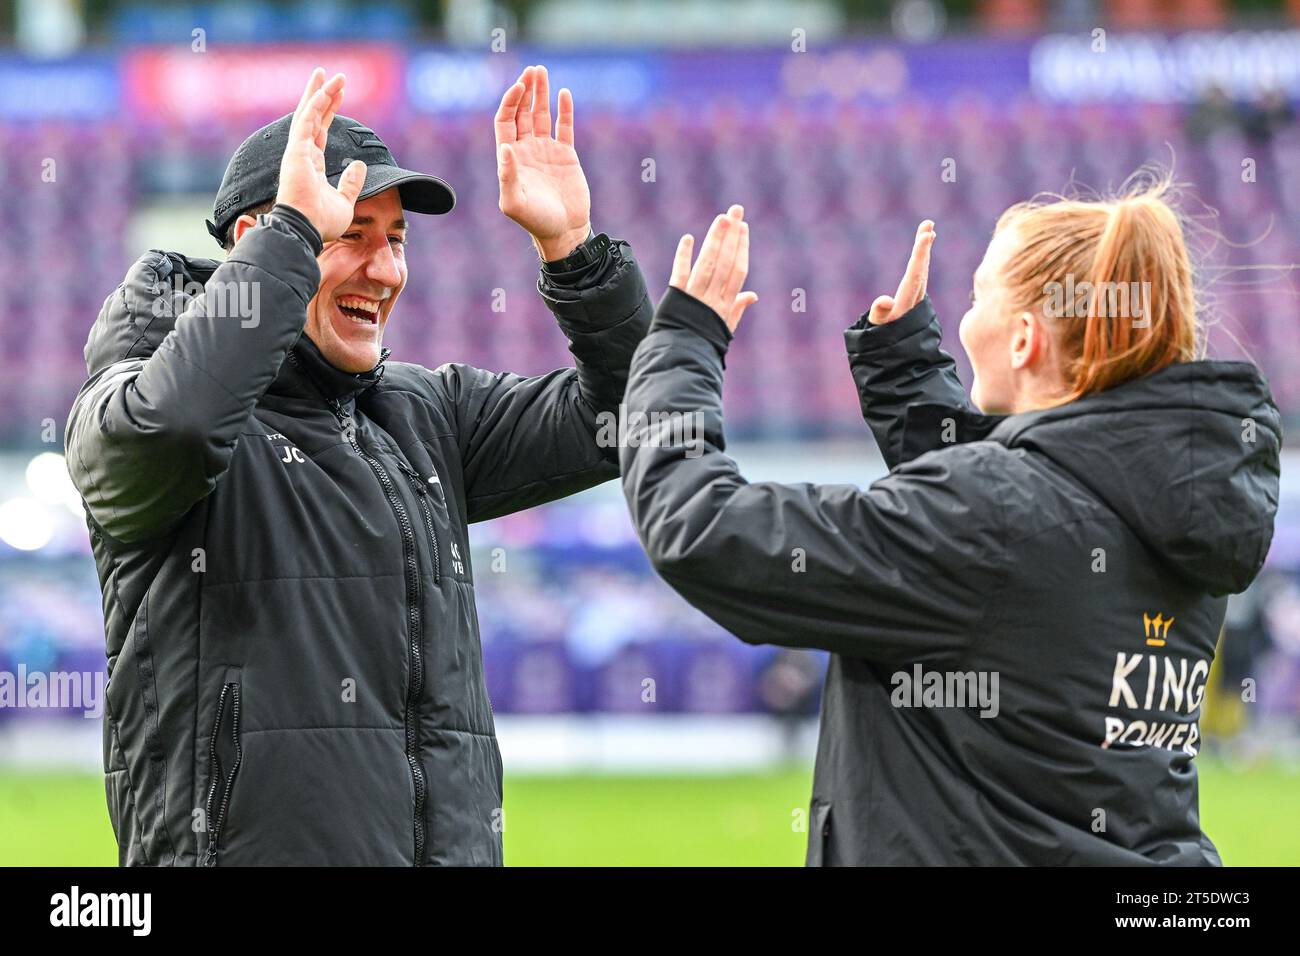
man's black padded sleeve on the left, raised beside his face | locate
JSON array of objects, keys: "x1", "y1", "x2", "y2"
[{"x1": 66, "y1": 209, "x2": 320, "y2": 544}]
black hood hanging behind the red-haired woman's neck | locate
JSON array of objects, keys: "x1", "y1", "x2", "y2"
[{"x1": 988, "y1": 362, "x2": 1282, "y2": 594}]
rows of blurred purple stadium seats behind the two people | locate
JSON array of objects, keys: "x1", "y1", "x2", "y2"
[{"x1": 0, "y1": 95, "x2": 1300, "y2": 445}]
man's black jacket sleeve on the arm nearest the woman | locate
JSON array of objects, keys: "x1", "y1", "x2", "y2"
[{"x1": 436, "y1": 242, "x2": 653, "y2": 522}]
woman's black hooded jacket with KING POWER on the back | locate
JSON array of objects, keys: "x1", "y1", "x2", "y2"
[{"x1": 620, "y1": 290, "x2": 1282, "y2": 865}]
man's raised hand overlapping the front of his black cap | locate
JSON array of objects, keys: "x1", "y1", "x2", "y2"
[{"x1": 276, "y1": 66, "x2": 365, "y2": 242}]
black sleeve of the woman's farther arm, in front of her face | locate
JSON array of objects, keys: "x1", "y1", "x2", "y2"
[{"x1": 844, "y1": 295, "x2": 974, "y2": 468}]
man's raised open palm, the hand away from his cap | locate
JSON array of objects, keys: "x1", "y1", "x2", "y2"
[{"x1": 495, "y1": 66, "x2": 592, "y2": 260}]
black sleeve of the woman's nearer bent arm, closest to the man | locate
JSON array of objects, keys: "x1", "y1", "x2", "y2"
[{"x1": 621, "y1": 290, "x2": 1005, "y2": 662}]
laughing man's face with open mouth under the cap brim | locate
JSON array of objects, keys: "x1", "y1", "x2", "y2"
[{"x1": 306, "y1": 187, "x2": 407, "y2": 372}]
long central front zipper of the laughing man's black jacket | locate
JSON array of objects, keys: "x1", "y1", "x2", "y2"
[{"x1": 287, "y1": 350, "x2": 426, "y2": 866}]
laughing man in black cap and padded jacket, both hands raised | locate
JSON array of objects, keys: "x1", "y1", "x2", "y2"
[{"x1": 66, "y1": 68, "x2": 651, "y2": 865}]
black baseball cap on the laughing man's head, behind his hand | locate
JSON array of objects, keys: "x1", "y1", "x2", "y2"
[{"x1": 207, "y1": 113, "x2": 456, "y2": 246}]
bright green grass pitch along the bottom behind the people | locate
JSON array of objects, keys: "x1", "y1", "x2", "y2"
[{"x1": 0, "y1": 760, "x2": 1300, "y2": 866}]
